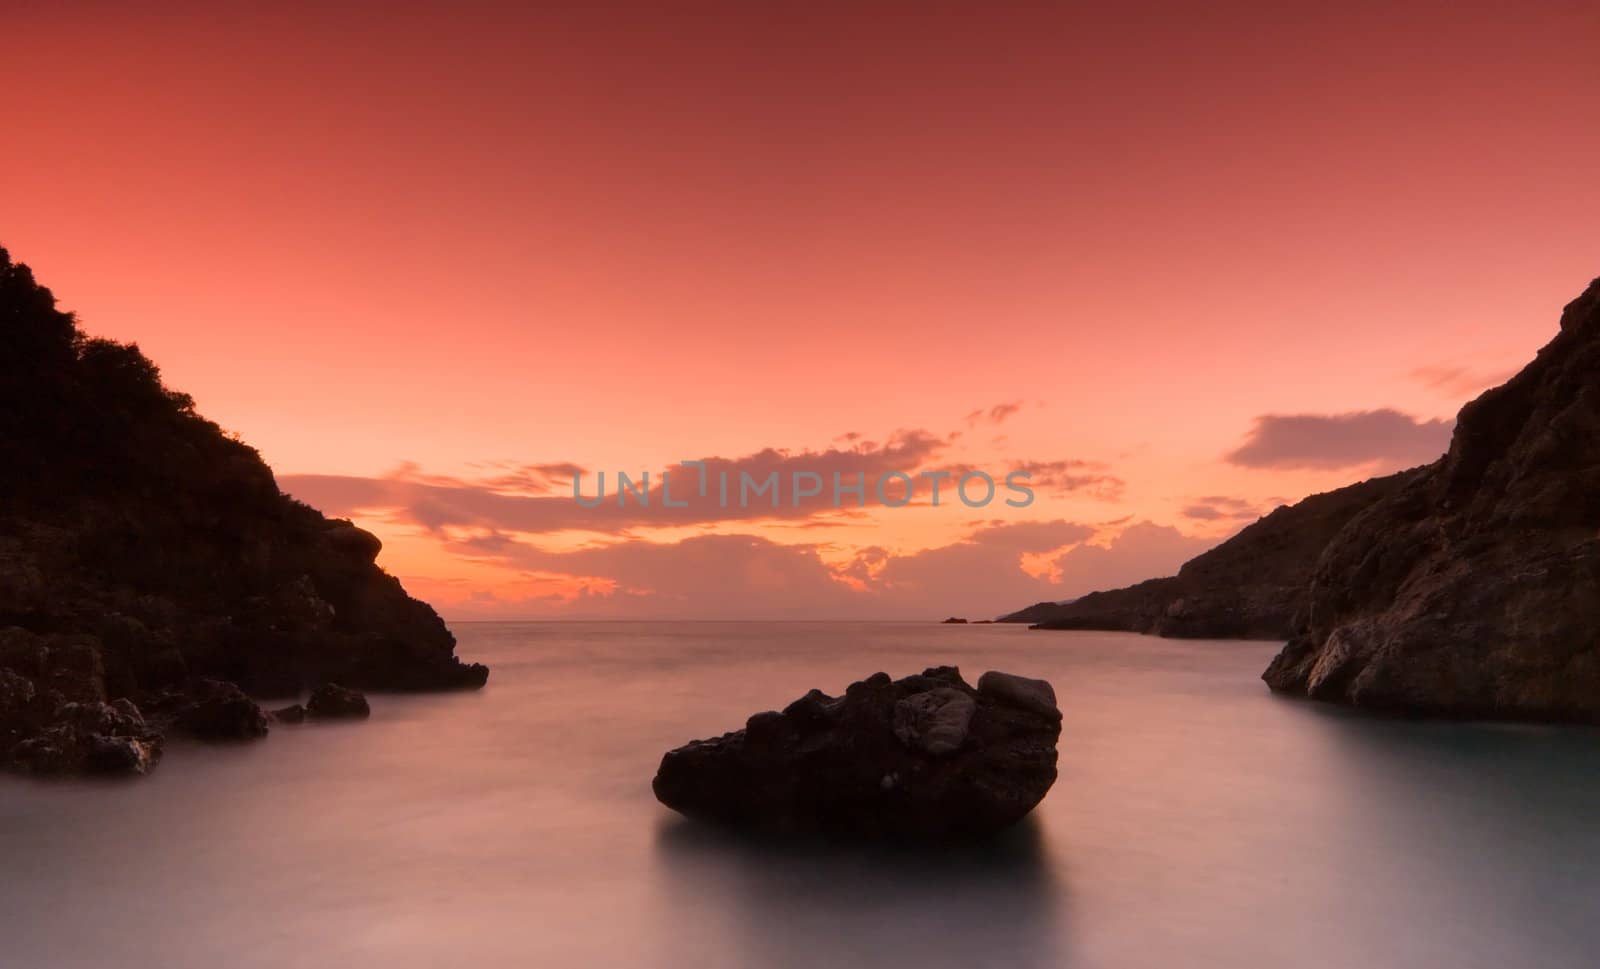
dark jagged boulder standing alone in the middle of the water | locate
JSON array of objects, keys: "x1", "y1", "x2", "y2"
[{"x1": 653, "y1": 667, "x2": 1061, "y2": 839}]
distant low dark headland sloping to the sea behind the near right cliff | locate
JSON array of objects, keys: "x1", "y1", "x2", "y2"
[{"x1": 1002, "y1": 470, "x2": 1418, "y2": 640}]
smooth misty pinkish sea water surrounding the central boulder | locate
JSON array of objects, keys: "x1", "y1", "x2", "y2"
[{"x1": 0, "y1": 624, "x2": 1600, "y2": 969}]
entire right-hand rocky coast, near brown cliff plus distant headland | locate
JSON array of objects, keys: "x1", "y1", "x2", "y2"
[{"x1": 1002, "y1": 271, "x2": 1600, "y2": 723}]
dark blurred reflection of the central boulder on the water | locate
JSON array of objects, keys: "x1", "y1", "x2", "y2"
[{"x1": 656, "y1": 817, "x2": 1067, "y2": 969}]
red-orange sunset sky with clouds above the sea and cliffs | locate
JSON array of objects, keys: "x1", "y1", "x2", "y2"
[{"x1": 0, "y1": 0, "x2": 1600, "y2": 619}]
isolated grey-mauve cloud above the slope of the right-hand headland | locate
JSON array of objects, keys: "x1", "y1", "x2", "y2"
[{"x1": 1227, "y1": 408, "x2": 1454, "y2": 470}]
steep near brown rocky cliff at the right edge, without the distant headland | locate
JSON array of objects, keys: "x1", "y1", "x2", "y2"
[{"x1": 1264, "y1": 280, "x2": 1600, "y2": 721}]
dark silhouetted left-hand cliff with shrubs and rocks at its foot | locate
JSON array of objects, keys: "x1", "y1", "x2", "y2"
[{"x1": 0, "y1": 249, "x2": 488, "y2": 769}]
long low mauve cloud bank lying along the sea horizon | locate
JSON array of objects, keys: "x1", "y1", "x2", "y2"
[{"x1": 412, "y1": 520, "x2": 1213, "y2": 619}]
